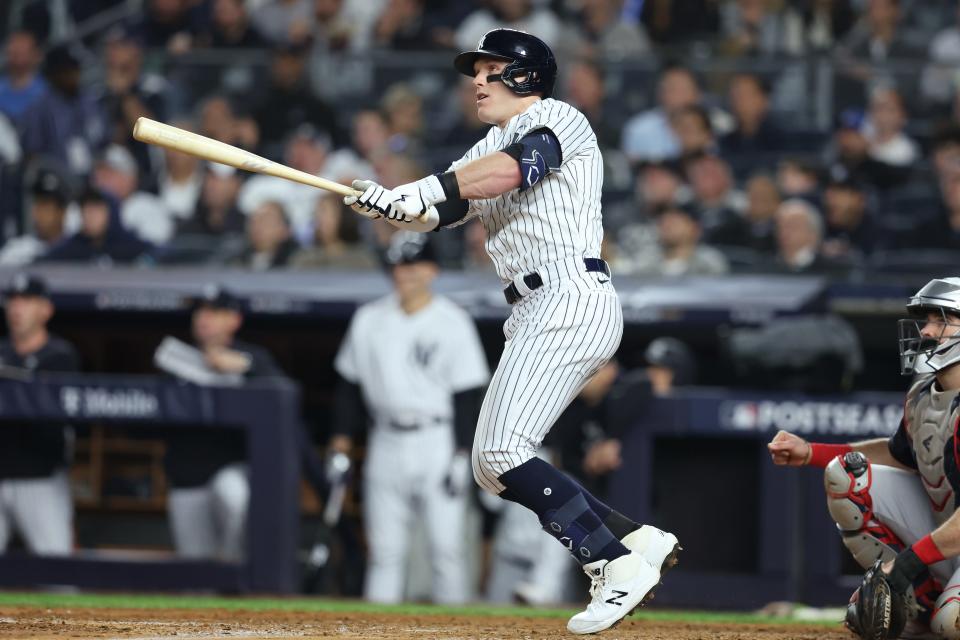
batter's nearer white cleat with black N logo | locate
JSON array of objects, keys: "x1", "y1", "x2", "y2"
[{"x1": 567, "y1": 552, "x2": 660, "y2": 635}]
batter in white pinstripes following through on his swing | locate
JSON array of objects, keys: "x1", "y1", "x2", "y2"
[{"x1": 344, "y1": 29, "x2": 679, "y2": 634}]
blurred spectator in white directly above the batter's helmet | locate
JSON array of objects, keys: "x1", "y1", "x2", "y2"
[{"x1": 454, "y1": 0, "x2": 563, "y2": 51}]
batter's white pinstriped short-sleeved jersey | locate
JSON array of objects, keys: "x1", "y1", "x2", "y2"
[{"x1": 442, "y1": 98, "x2": 603, "y2": 283}]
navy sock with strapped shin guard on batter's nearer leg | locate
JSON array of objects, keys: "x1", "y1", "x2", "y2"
[{"x1": 499, "y1": 458, "x2": 630, "y2": 564}]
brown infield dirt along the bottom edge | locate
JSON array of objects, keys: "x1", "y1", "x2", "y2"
[{"x1": 0, "y1": 607, "x2": 852, "y2": 640}]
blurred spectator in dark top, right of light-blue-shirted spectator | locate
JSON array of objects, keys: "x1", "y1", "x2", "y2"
[{"x1": 720, "y1": 73, "x2": 784, "y2": 155}]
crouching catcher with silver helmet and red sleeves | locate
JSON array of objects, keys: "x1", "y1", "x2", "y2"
[{"x1": 767, "y1": 278, "x2": 960, "y2": 640}]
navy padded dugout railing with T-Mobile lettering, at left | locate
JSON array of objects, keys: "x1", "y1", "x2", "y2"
[{"x1": 0, "y1": 374, "x2": 302, "y2": 593}]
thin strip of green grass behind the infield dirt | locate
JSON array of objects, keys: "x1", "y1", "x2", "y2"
[{"x1": 0, "y1": 592, "x2": 837, "y2": 625}]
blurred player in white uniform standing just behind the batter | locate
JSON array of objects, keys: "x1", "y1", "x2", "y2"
[{"x1": 333, "y1": 231, "x2": 490, "y2": 603}]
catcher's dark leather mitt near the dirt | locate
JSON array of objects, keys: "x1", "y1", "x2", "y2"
[{"x1": 845, "y1": 548, "x2": 927, "y2": 640}]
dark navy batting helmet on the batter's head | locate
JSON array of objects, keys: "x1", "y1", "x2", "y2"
[{"x1": 453, "y1": 29, "x2": 557, "y2": 98}]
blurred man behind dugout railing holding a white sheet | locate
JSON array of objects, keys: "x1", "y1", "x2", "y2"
[{"x1": 154, "y1": 286, "x2": 283, "y2": 562}]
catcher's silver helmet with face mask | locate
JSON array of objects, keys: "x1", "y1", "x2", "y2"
[{"x1": 898, "y1": 278, "x2": 960, "y2": 376}]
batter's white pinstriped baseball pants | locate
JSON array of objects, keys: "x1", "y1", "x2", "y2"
[{"x1": 472, "y1": 259, "x2": 623, "y2": 494}]
